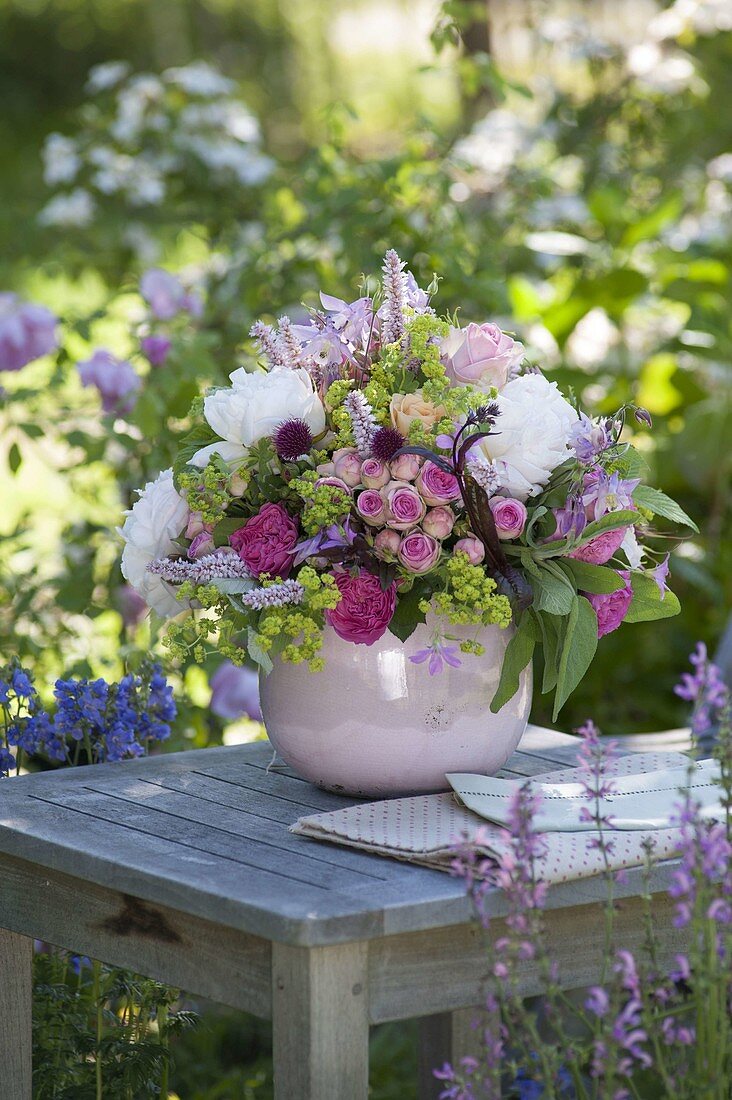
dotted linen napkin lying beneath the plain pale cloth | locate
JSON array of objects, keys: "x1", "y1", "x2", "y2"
[{"x1": 291, "y1": 752, "x2": 708, "y2": 883}]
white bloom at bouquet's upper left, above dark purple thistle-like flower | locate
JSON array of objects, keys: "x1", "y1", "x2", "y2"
[{"x1": 192, "y1": 367, "x2": 326, "y2": 465}]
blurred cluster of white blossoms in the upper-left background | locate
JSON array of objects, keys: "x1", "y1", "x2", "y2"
[{"x1": 41, "y1": 62, "x2": 274, "y2": 227}]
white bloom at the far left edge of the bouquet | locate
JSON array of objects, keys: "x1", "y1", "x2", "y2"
[{"x1": 120, "y1": 470, "x2": 188, "y2": 618}]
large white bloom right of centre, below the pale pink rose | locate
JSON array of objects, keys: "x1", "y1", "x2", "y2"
[{"x1": 478, "y1": 374, "x2": 578, "y2": 501}]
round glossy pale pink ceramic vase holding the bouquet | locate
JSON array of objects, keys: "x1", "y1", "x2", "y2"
[{"x1": 260, "y1": 624, "x2": 532, "y2": 798}]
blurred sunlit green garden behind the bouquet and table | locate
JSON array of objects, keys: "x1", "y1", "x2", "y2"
[{"x1": 0, "y1": 0, "x2": 732, "y2": 1100}]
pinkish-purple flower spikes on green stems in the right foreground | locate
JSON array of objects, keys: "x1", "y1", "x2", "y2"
[{"x1": 435, "y1": 648, "x2": 732, "y2": 1100}]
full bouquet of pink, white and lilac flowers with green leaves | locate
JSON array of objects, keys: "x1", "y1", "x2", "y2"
[{"x1": 122, "y1": 251, "x2": 695, "y2": 715}]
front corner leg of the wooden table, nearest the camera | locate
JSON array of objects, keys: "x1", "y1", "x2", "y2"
[{"x1": 272, "y1": 943, "x2": 369, "y2": 1100}]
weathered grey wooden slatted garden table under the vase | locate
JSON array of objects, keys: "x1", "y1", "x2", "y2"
[{"x1": 0, "y1": 727, "x2": 678, "y2": 1100}]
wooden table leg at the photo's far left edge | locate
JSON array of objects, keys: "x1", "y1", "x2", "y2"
[{"x1": 0, "y1": 928, "x2": 33, "y2": 1100}]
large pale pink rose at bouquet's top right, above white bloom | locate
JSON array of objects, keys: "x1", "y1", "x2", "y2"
[{"x1": 441, "y1": 321, "x2": 524, "y2": 389}]
